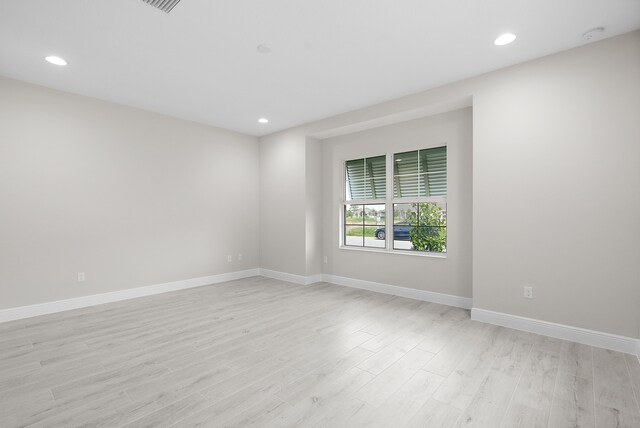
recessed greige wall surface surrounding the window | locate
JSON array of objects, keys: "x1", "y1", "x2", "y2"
[{"x1": 322, "y1": 108, "x2": 472, "y2": 297}]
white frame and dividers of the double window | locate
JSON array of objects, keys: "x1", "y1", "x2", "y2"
[{"x1": 338, "y1": 143, "x2": 450, "y2": 259}]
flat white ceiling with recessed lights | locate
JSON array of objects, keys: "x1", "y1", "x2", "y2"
[{"x1": 0, "y1": 0, "x2": 640, "y2": 135}]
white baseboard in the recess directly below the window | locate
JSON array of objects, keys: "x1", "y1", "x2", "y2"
[{"x1": 322, "y1": 274, "x2": 472, "y2": 309}]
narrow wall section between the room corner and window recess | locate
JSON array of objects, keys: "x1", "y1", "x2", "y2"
[{"x1": 259, "y1": 132, "x2": 323, "y2": 276}]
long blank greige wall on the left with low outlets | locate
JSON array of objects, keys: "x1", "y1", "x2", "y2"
[{"x1": 0, "y1": 78, "x2": 259, "y2": 308}]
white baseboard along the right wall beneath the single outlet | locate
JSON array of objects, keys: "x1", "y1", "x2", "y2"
[{"x1": 471, "y1": 308, "x2": 640, "y2": 355}]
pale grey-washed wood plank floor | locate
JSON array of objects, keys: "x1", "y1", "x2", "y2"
[{"x1": 0, "y1": 277, "x2": 640, "y2": 428}]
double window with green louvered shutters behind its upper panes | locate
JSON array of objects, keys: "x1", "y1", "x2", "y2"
[{"x1": 342, "y1": 146, "x2": 447, "y2": 253}]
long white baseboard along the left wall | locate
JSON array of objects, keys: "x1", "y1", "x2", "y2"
[{"x1": 0, "y1": 269, "x2": 260, "y2": 322}]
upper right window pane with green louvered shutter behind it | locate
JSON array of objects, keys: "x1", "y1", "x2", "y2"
[{"x1": 393, "y1": 146, "x2": 447, "y2": 198}]
